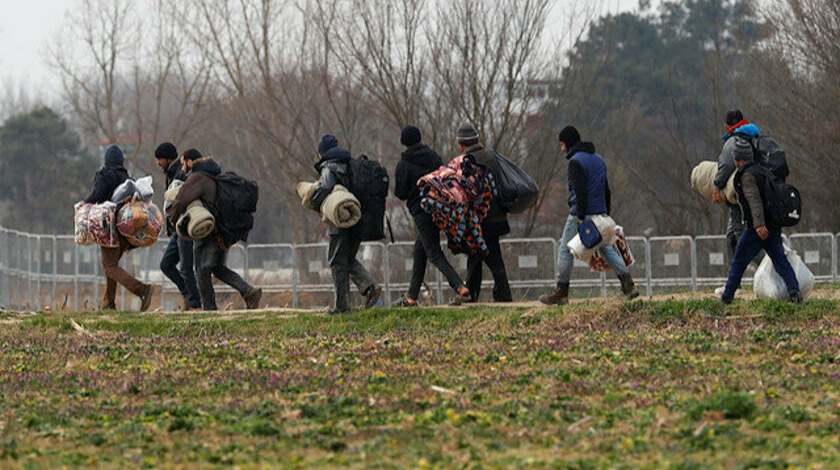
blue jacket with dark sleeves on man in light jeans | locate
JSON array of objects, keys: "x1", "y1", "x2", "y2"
[{"x1": 566, "y1": 142, "x2": 612, "y2": 219}]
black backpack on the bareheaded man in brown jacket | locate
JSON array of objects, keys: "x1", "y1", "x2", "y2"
[{"x1": 211, "y1": 171, "x2": 260, "y2": 246}]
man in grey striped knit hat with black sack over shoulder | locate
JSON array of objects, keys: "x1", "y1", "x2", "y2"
[{"x1": 455, "y1": 122, "x2": 513, "y2": 302}]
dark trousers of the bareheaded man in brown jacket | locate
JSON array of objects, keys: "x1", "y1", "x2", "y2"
[{"x1": 193, "y1": 235, "x2": 253, "y2": 310}]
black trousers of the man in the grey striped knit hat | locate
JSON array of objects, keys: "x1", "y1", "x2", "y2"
[{"x1": 467, "y1": 222, "x2": 513, "y2": 302}]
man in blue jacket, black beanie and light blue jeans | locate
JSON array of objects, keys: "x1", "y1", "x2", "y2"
[{"x1": 539, "y1": 126, "x2": 639, "y2": 305}]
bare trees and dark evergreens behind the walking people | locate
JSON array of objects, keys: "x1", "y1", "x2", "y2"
[{"x1": 0, "y1": 0, "x2": 840, "y2": 242}]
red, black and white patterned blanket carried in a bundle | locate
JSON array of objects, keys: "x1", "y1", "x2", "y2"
[{"x1": 417, "y1": 155, "x2": 496, "y2": 254}]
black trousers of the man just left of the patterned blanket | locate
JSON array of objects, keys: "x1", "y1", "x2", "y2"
[{"x1": 407, "y1": 212, "x2": 462, "y2": 300}]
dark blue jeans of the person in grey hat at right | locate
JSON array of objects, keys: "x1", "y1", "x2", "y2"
[{"x1": 721, "y1": 228, "x2": 799, "y2": 300}]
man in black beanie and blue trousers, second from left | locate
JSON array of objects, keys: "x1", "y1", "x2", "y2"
[{"x1": 155, "y1": 142, "x2": 201, "y2": 310}]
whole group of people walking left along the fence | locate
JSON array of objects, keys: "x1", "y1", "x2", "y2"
[{"x1": 85, "y1": 110, "x2": 802, "y2": 313}]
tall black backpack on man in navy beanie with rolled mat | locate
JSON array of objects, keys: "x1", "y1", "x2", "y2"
[{"x1": 350, "y1": 155, "x2": 390, "y2": 241}]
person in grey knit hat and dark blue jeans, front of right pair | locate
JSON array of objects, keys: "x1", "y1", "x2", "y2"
[{"x1": 720, "y1": 138, "x2": 802, "y2": 304}]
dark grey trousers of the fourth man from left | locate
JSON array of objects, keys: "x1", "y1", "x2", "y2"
[{"x1": 329, "y1": 229, "x2": 376, "y2": 311}]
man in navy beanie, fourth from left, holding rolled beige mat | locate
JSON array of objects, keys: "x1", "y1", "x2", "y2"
[{"x1": 311, "y1": 134, "x2": 382, "y2": 313}]
